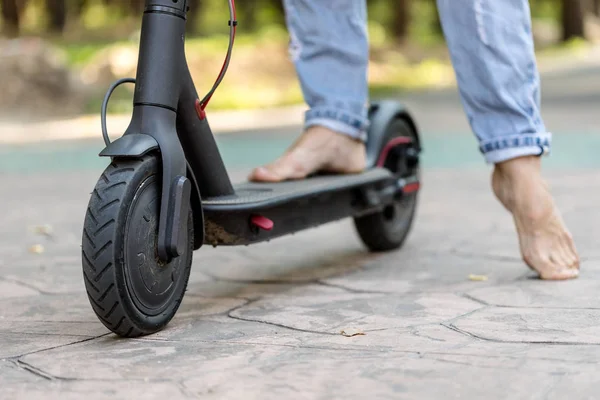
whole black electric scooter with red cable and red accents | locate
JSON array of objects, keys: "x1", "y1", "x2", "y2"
[{"x1": 82, "y1": 0, "x2": 421, "y2": 337}]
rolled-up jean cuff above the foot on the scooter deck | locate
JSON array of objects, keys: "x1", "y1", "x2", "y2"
[{"x1": 304, "y1": 109, "x2": 369, "y2": 141}]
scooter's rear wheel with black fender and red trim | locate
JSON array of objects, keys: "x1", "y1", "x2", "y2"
[{"x1": 354, "y1": 118, "x2": 420, "y2": 251}]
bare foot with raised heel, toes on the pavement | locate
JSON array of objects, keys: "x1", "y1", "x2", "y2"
[{"x1": 492, "y1": 157, "x2": 579, "y2": 280}]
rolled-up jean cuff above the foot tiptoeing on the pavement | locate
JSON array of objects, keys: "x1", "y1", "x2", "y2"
[{"x1": 479, "y1": 132, "x2": 552, "y2": 164}]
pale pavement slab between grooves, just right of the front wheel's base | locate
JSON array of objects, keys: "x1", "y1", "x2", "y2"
[{"x1": 229, "y1": 286, "x2": 481, "y2": 335}]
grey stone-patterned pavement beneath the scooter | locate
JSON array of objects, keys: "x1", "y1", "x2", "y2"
[{"x1": 0, "y1": 163, "x2": 600, "y2": 399}]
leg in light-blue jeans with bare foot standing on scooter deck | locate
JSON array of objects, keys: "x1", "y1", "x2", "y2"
[{"x1": 250, "y1": 0, "x2": 369, "y2": 181}]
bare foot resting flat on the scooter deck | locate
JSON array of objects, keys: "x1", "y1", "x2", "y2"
[{"x1": 248, "y1": 126, "x2": 367, "y2": 182}]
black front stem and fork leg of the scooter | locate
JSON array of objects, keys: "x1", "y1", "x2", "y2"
[{"x1": 130, "y1": 0, "x2": 189, "y2": 261}]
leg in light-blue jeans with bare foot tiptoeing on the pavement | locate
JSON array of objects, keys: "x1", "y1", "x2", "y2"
[{"x1": 438, "y1": 0, "x2": 579, "y2": 279}]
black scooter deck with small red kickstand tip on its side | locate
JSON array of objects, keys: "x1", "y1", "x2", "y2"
[{"x1": 202, "y1": 168, "x2": 395, "y2": 246}]
